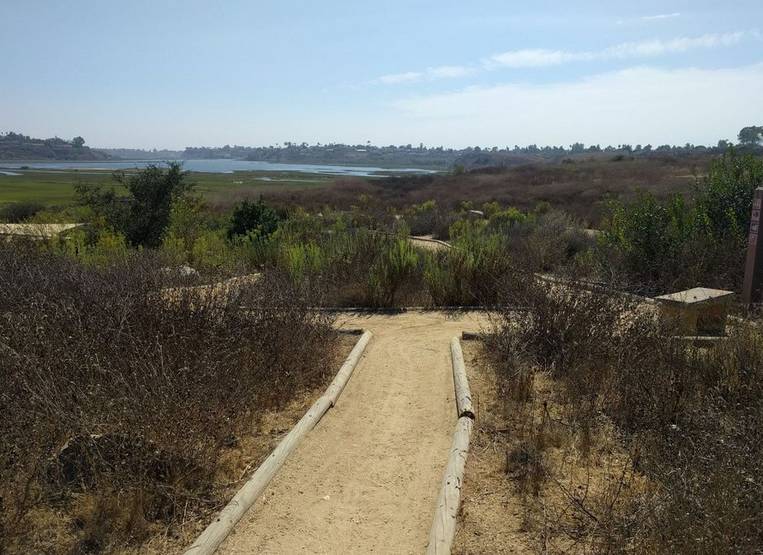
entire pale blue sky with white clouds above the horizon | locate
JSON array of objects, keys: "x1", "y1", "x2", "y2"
[{"x1": 0, "y1": 0, "x2": 763, "y2": 148}]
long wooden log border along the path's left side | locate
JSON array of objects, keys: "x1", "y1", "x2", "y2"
[{"x1": 185, "y1": 331, "x2": 372, "y2": 555}]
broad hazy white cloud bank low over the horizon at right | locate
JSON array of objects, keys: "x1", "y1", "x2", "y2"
[{"x1": 387, "y1": 64, "x2": 763, "y2": 146}]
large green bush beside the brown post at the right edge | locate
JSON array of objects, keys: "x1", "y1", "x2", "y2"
[{"x1": 601, "y1": 150, "x2": 763, "y2": 290}]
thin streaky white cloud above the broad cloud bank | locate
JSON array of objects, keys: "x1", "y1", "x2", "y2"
[{"x1": 490, "y1": 31, "x2": 745, "y2": 69}]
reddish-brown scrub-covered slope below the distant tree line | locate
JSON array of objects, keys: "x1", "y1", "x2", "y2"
[{"x1": 265, "y1": 156, "x2": 711, "y2": 226}]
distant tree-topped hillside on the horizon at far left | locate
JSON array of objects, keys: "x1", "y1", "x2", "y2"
[{"x1": 0, "y1": 132, "x2": 111, "y2": 160}]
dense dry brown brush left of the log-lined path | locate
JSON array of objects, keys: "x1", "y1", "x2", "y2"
[{"x1": 0, "y1": 245, "x2": 332, "y2": 552}]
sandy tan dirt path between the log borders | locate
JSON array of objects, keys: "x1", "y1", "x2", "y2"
[{"x1": 220, "y1": 313, "x2": 490, "y2": 553}]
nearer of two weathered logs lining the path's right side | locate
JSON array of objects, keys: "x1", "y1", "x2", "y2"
[{"x1": 427, "y1": 416, "x2": 473, "y2": 555}]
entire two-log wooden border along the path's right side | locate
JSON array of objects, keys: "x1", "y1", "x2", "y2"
[{"x1": 427, "y1": 337, "x2": 474, "y2": 555}]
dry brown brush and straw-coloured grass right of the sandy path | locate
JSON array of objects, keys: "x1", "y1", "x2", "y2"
[{"x1": 492, "y1": 278, "x2": 763, "y2": 553}]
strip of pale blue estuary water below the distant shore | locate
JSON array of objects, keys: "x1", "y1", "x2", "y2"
[{"x1": 0, "y1": 159, "x2": 435, "y2": 177}]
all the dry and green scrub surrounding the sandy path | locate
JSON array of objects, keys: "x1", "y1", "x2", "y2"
[{"x1": 0, "y1": 146, "x2": 763, "y2": 552}]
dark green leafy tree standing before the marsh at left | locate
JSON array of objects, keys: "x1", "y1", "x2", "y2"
[{"x1": 75, "y1": 162, "x2": 193, "y2": 247}]
